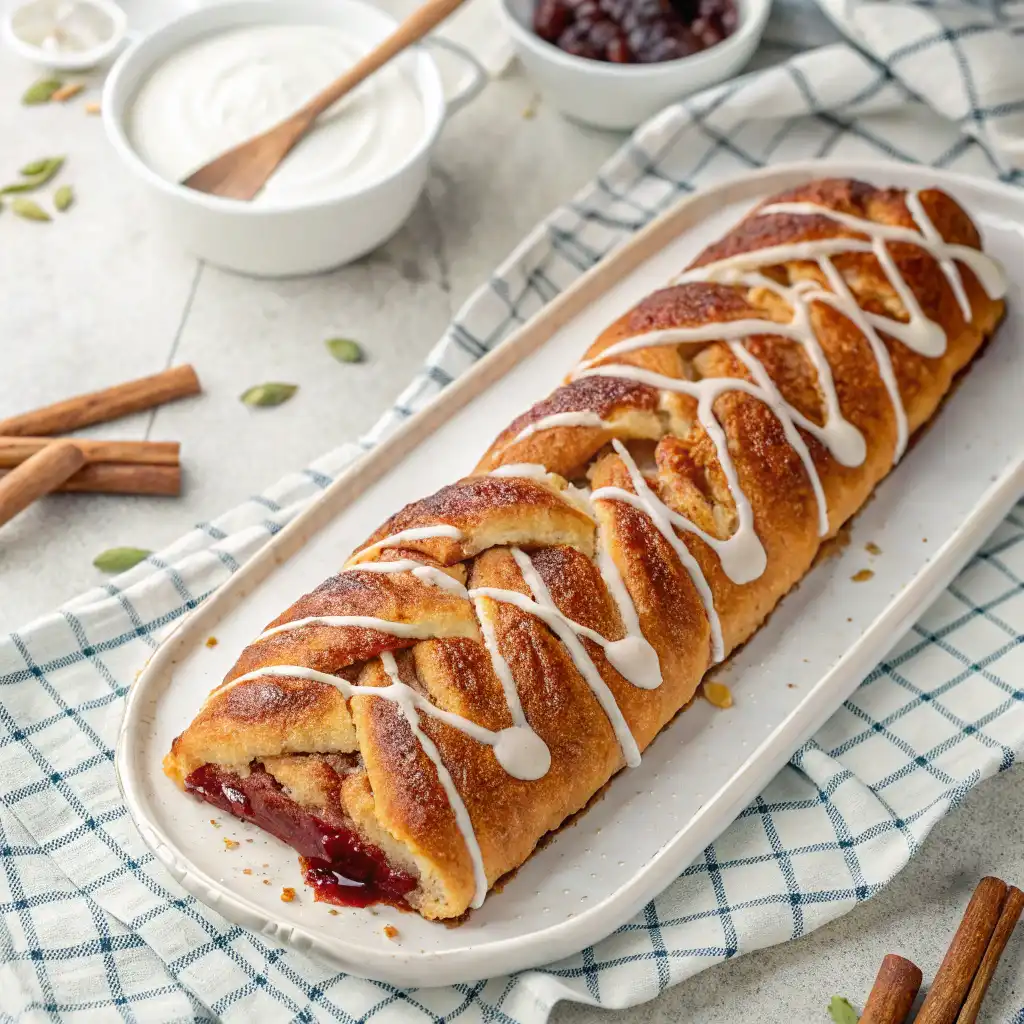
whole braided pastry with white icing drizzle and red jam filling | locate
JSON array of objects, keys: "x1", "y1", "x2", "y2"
[{"x1": 165, "y1": 180, "x2": 1005, "y2": 918}]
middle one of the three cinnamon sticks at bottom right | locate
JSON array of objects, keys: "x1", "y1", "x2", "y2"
[{"x1": 916, "y1": 876, "x2": 1007, "y2": 1024}]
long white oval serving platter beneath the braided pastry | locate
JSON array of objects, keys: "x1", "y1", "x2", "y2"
[{"x1": 117, "y1": 162, "x2": 1024, "y2": 986}]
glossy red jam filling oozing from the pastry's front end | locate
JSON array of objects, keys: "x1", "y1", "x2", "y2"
[{"x1": 185, "y1": 764, "x2": 416, "y2": 908}]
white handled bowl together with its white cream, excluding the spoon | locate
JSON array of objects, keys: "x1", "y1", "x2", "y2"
[{"x1": 102, "y1": 0, "x2": 484, "y2": 276}]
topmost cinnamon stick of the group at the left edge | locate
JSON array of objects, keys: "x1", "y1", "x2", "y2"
[{"x1": 0, "y1": 366, "x2": 200, "y2": 437}]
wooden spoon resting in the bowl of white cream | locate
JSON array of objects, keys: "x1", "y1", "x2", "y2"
[{"x1": 181, "y1": 0, "x2": 463, "y2": 200}]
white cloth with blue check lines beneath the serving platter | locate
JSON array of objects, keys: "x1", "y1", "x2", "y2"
[{"x1": 0, "y1": 0, "x2": 1024, "y2": 1024}]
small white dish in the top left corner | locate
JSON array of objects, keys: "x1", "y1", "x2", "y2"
[{"x1": 0, "y1": 0, "x2": 128, "y2": 71}]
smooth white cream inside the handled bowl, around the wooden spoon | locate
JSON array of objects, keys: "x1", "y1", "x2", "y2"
[{"x1": 128, "y1": 25, "x2": 427, "y2": 205}]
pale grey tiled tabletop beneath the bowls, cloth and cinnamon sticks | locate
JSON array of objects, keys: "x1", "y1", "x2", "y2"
[{"x1": 0, "y1": 9, "x2": 1024, "y2": 1024}]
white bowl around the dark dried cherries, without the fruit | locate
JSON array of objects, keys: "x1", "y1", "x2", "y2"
[{"x1": 501, "y1": 0, "x2": 771, "y2": 129}]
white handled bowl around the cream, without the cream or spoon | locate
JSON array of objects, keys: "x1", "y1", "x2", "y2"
[{"x1": 102, "y1": 0, "x2": 486, "y2": 278}]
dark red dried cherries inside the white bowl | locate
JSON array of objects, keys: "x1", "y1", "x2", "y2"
[{"x1": 534, "y1": 0, "x2": 738, "y2": 63}]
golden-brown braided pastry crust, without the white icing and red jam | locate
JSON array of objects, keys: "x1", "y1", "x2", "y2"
[{"x1": 166, "y1": 180, "x2": 1002, "y2": 918}]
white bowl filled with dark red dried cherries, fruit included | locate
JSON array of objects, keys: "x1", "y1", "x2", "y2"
[{"x1": 501, "y1": 0, "x2": 771, "y2": 129}]
